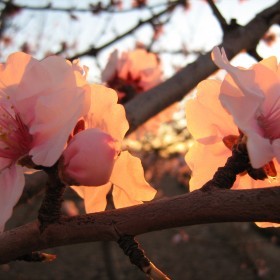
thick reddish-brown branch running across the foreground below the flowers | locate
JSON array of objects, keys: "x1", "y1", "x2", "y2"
[{"x1": 0, "y1": 187, "x2": 280, "y2": 263}]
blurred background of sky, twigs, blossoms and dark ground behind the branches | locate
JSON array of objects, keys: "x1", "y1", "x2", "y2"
[{"x1": 0, "y1": 0, "x2": 280, "y2": 280}]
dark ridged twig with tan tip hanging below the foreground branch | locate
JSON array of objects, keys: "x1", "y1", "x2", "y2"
[{"x1": 118, "y1": 235, "x2": 170, "y2": 280}]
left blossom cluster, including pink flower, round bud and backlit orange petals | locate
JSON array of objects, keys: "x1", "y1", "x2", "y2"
[{"x1": 0, "y1": 53, "x2": 155, "y2": 231}]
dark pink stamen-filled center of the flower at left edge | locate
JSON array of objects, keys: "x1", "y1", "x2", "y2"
[{"x1": 0, "y1": 105, "x2": 32, "y2": 161}]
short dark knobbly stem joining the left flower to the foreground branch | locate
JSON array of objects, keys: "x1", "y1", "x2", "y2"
[{"x1": 38, "y1": 164, "x2": 66, "y2": 231}]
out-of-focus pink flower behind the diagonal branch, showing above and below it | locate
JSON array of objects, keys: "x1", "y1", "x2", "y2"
[{"x1": 102, "y1": 48, "x2": 177, "y2": 140}]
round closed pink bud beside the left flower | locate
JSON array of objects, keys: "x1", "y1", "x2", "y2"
[{"x1": 60, "y1": 128, "x2": 118, "y2": 186}]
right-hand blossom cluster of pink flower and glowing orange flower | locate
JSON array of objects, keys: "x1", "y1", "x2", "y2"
[{"x1": 186, "y1": 47, "x2": 280, "y2": 226}]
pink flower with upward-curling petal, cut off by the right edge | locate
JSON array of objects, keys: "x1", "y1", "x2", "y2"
[{"x1": 213, "y1": 47, "x2": 280, "y2": 168}]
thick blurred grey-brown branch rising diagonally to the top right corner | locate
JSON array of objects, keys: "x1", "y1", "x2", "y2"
[{"x1": 125, "y1": 1, "x2": 280, "y2": 132}]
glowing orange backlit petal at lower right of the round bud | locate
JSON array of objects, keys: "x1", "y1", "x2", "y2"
[{"x1": 110, "y1": 151, "x2": 156, "y2": 207}]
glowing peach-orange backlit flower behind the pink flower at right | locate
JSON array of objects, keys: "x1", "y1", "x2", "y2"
[{"x1": 186, "y1": 80, "x2": 270, "y2": 191}]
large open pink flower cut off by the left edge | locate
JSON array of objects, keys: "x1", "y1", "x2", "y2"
[{"x1": 0, "y1": 53, "x2": 90, "y2": 230}]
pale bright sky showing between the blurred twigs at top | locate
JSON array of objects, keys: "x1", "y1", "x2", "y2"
[{"x1": 0, "y1": 0, "x2": 280, "y2": 82}]
